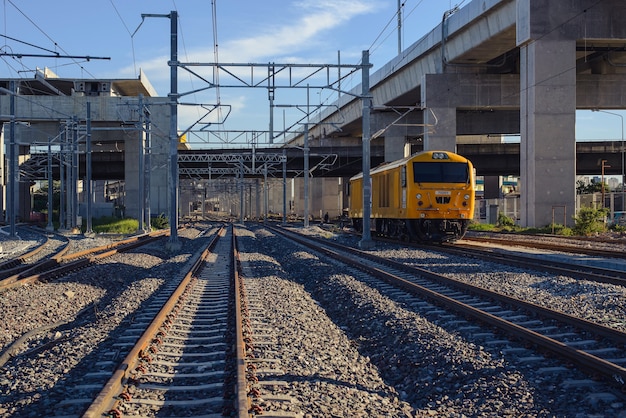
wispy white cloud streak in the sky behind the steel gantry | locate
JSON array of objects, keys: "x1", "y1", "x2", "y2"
[{"x1": 113, "y1": 0, "x2": 379, "y2": 134}]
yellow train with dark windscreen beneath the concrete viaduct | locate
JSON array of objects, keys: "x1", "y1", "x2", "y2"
[{"x1": 349, "y1": 151, "x2": 475, "y2": 242}]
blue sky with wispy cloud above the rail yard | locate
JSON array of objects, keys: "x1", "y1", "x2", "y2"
[{"x1": 0, "y1": 0, "x2": 622, "y2": 146}]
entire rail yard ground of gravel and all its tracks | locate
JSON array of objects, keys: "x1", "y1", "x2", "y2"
[{"x1": 0, "y1": 221, "x2": 626, "y2": 418}]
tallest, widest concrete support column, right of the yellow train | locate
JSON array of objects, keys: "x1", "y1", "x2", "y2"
[{"x1": 520, "y1": 38, "x2": 576, "y2": 227}]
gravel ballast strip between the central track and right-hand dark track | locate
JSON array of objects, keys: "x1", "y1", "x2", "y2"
[{"x1": 239, "y1": 228, "x2": 626, "y2": 417}]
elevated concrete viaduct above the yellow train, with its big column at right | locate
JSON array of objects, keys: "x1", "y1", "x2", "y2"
[{"x1": 294, "y1": 0, "x2": 626, "y2": 226}]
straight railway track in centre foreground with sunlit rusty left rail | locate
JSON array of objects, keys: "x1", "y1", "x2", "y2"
[{"x1": 83, "y1": 227, "x2": 247, "y2": 417}]
